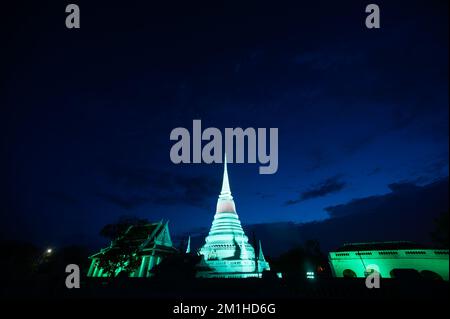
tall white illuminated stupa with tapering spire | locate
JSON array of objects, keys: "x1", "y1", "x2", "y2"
[{"x1": 197, "y1": 155, "x2": 270, "y2": 278}]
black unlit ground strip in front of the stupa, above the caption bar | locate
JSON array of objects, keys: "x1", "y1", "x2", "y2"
[{"x1": 0, "y1": 278, "x2": 449, "y2": 300}]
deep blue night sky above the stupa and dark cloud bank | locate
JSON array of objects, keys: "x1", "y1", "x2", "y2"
[{"x1": 0, "y1": 1, "x2": 449, "y2": 251}]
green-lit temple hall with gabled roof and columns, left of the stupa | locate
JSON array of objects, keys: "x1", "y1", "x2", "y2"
[{"x1": 87, "y1": 221, "x2": 177, "y2": 277}]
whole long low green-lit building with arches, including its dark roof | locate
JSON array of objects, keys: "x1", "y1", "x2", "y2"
[{"x1": 328, "y1": 242, "x2": 449, "y2": 281}]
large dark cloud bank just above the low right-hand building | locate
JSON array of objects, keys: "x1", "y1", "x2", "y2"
[{"x1": 299, "y1": 177, "x2": 449, "y2": 249}]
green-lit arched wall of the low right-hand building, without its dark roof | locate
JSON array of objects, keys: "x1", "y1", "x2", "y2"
[{"x1": 329, "y1": 249, "x2": 449, "y2": 280}]
